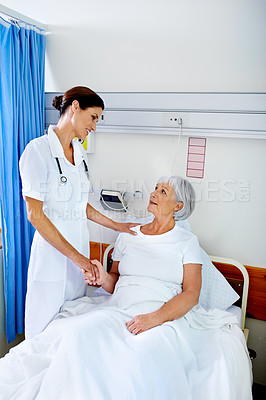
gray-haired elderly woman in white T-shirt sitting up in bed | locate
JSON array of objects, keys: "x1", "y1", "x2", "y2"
[{"x1": 84, "y1": 176, "x2": 201, "y2": 334}]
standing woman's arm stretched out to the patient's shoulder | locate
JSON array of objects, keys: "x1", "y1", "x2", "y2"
[{"x1": 86, "y1": 203, "x2": 139, "y2": 235}]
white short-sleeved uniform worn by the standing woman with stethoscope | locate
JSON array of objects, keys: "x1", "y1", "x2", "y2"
[{"x1": 20, "y1": 126, "x2": 90, "y2": 339}]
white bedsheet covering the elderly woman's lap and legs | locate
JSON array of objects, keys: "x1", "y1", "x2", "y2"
[{"x1": 0, "y1": 277, "x2": 252, "y2": 400}]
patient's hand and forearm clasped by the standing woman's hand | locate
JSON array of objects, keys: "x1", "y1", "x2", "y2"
[{"x1": 83, "y1": 260, "x2": 120, "y2": 293}]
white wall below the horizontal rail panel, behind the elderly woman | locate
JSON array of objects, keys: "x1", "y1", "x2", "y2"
[{"x1": 85, "y1": 133, "x2": 266, "y2": 267}]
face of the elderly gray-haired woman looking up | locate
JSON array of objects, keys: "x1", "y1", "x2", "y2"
[{"x1": 147, "y1": 182, "x2": 182, "y2": 217}]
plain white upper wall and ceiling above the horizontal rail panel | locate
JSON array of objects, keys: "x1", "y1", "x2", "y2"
[{"x1": 2, "y1": 0, "x2": 266, "y2": 92}]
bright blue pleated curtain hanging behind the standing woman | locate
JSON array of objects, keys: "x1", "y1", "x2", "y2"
[{"x1": 0, "y1": 18, "x2": 45, "y2": 343}]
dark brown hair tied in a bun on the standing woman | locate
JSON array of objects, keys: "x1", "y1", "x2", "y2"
[{"x1": 52, "y1": 86, "x2": 104, "y2": 117}]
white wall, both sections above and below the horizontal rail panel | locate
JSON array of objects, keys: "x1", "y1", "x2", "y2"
[{"x1": 1, "y1": 0, "x2": 266, "y2": 266}]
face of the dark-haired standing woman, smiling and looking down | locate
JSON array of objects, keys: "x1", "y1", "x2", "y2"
[{"x1": 72, "y1": 105, "x2": 103, "y2": 140}]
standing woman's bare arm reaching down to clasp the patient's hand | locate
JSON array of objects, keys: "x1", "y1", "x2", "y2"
[{"x1": 26, "y1": 197, "x2": 97, "y2": 277}]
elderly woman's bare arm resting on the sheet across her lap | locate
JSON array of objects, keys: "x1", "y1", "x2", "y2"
[{"x1": 126, "y1": 264, "x2": 201, "y2": 334}]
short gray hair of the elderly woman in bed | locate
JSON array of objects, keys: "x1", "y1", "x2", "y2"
[{"x1": 158, "y1": 175, "x2": 196, "y2": 221}]
